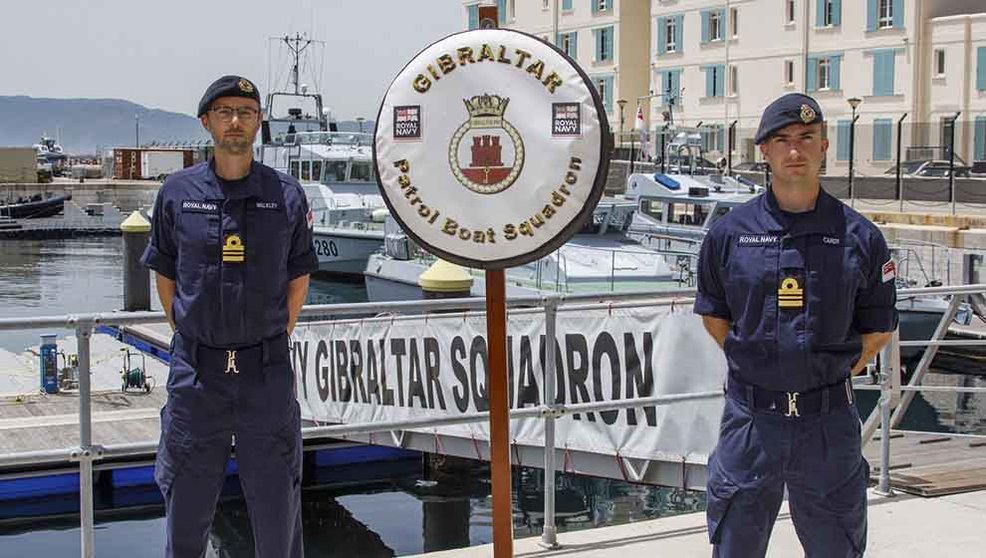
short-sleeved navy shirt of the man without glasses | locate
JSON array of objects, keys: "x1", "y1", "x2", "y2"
[{"x1": 695, "y1": 190, "x2": 897, "y2": 392}]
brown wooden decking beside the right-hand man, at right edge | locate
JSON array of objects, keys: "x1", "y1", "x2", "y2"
[{"x1": 864, "y1": 430, "x2": 986, "y2": 496}]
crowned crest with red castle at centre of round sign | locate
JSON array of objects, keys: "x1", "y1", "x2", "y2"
[{"x1": 449, "y1": 93, "x2": 524, "y2": 194}]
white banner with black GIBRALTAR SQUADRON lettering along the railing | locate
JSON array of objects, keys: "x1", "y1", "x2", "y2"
[{"x1": 292, "y1": 307, "x2": 726, "y2": 459}]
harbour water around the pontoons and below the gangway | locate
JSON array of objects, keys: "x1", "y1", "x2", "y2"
[{"x1": 0, "y1": 238, "x2": 986, "y2": 557}]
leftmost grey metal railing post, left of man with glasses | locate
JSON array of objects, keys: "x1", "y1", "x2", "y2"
[{"x1": 75, "y1": 319, "x2": 95, "y2": 558}]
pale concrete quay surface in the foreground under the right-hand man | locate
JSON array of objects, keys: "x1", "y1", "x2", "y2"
[{"x1": 411, "y1": 491, "x2": 986, "y2": 558}]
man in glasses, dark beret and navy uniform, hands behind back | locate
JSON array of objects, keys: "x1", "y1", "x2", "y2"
[{"x1": 143, "y1": 76, "x2": 318, "y2": 558}]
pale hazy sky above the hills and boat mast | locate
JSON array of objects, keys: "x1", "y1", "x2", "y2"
[{"x1": 0, "y1": 0, "x2": 465, "y2": 120}]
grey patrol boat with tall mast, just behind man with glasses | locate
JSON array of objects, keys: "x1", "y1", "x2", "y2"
[{"x1": 255, "y1": 35, "x2": 386, "y2": 276}]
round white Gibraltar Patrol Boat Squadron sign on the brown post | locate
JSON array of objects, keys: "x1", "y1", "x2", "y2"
[{"x1": 374, "y1": 29, "x2": 610, "y2": 269}]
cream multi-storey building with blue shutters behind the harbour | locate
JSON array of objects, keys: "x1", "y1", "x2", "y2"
[{"x1": 465, "y1": 0, "x2": 986, "y2": 174}]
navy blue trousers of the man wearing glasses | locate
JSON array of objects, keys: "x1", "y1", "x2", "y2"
[{"x1": 154, "y1": 334, "x2": 303, "y2": 558}]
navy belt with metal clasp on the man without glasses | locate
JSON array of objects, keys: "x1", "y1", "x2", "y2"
[{"x1": 726, "y1": 376, "x2": 853, "y2": 417}]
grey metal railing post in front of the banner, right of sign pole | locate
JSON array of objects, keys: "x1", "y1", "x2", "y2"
[{"x1": 541, "y1": 296, "x2": 558, "y2": 549}]
